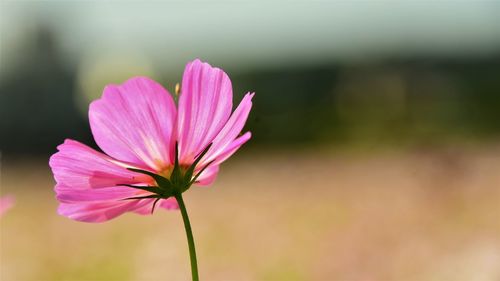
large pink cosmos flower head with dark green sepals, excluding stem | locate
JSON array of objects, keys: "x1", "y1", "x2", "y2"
[{"x1": 49, "y1": 59, "x2": 254, "y2": 222}]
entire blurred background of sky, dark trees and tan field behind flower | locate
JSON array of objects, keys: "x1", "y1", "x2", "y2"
[{"x1": 0, "y1": 1, "x2": 500, "y2": 281}]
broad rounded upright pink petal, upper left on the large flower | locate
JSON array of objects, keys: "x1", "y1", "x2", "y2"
[{"x1": 89, "y1": 77, "x2": 176, "y2": 171}]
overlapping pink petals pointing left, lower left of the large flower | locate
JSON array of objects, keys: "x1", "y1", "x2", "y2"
[{"x1": 49, "y1": 140, "x2": 156, "y2": 222}]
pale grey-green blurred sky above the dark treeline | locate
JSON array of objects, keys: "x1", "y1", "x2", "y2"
[{"x1": 0, "y1": 0, "x2": 500, "y2": 72}]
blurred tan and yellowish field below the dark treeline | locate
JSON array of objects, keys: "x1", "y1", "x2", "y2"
[{"x1": 0, "y1": 145, "x2": 500, "y2": 281}]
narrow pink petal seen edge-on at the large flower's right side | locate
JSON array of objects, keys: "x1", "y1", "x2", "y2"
[{"x1": 200, "y1": 93, "x2": 254, "y2": 167}]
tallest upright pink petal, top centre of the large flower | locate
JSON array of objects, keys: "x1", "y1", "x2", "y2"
[{"x1": 177, "y1": 59, "x2": 233, "y2": 164}]
